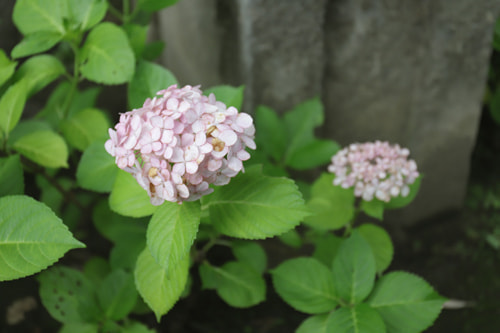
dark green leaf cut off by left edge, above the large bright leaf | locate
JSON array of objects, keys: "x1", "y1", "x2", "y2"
[{"x1": 0, "y1": 155, "x2": 24, "y2": 197}]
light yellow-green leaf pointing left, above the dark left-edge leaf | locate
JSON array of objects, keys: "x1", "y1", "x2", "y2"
[{"x1": 12, "y1": 131, "x2": 68, "y2": 168}]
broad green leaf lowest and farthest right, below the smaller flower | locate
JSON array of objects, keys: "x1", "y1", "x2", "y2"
[{"x1": 367, "y1": 272, "x2": 445, "y2": 333}]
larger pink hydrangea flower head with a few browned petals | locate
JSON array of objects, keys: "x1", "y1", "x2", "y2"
[{"x1": 105, "y1": 85, "x2": 256, "y2": 205}]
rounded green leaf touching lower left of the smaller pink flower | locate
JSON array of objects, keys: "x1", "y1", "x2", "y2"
[{"x1": 305, "y1": 173, "x2": 355, "y2": 230}]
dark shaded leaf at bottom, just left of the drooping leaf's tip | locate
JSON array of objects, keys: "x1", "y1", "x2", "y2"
[{"x1": 97, "y1": 270, "x2": 137, "y2": 320}]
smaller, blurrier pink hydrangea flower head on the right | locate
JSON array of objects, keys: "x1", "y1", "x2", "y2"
[{"x1": 328, "y1": 141, "x2": 419, "y2": 202}]
